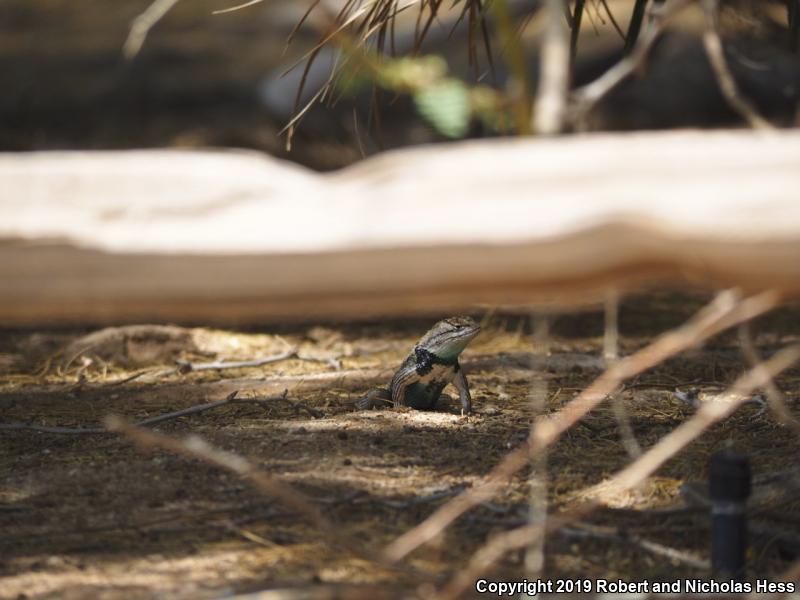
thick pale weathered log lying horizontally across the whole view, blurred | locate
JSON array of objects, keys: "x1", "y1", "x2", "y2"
[{"x1": 0, "y1": 131, "x2": 800, "y2": 325}]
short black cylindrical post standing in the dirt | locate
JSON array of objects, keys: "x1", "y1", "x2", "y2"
[{"x1": 709, "y1": 452, "x2": 750, "y2": 581}]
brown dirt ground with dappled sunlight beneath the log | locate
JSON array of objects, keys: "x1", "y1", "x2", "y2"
[{"x1": 0, "y1": 291, "x2": 800, "y2": 598}]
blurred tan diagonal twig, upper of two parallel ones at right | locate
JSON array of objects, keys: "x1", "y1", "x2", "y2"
[{"x1": 384, "y1": 291, "x2": 779, "y2": 561}]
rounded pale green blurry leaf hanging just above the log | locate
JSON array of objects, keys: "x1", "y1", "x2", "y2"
[{"x1": 414, "y1": 79, "x2": 472, "y2": 138}]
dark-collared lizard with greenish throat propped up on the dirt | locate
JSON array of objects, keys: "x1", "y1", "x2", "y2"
[{"x1": 356, "y1": 317, "x2": 480, "y2": 415}]
